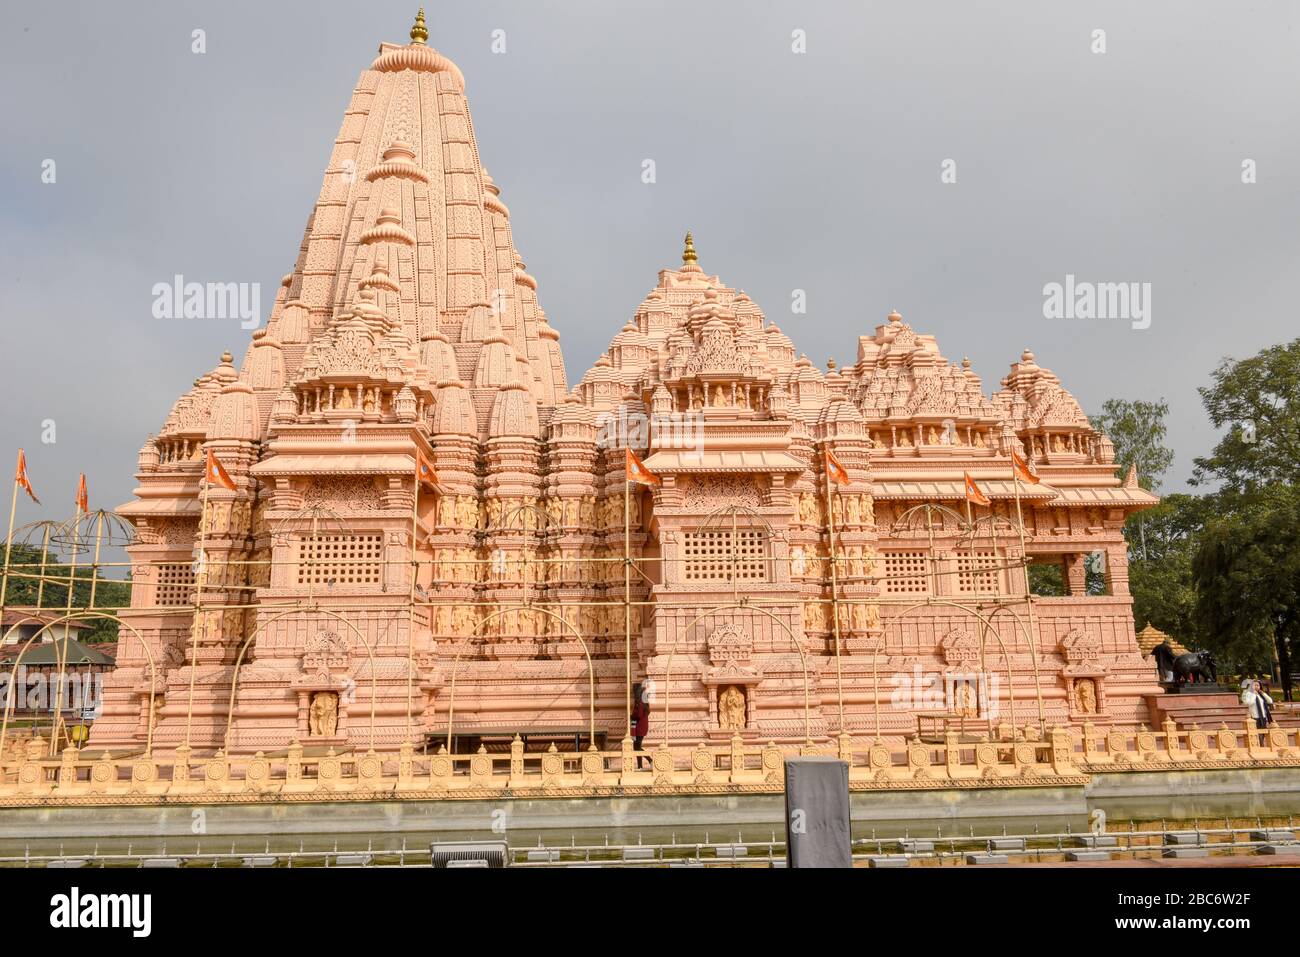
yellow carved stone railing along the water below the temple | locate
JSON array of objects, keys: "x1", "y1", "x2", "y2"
[{"x1": 0, "y1": 722, "x2": 1300, "y2": 806}]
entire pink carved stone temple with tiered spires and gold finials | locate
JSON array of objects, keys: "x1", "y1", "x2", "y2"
[{"x1": 90, "y1": 22, "x2": 1157, "y2": 753}]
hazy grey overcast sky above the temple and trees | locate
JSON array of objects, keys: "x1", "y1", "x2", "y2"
[{"x1": 0, "y1": 0, "x2": 1300, "y2": 535}]
